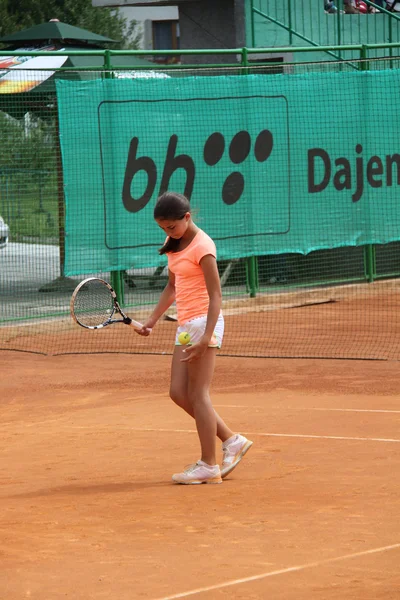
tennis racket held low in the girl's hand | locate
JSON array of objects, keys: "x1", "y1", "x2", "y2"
[{"x1": 70, "y1": 277, "x2": 143, "y2": 331}]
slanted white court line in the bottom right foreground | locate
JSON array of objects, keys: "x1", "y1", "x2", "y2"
[{"x1": 157, "y1": 544, "x2": 400, "y2": 600}]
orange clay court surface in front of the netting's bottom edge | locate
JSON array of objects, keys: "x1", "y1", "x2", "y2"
[{"x1": 0, "y1": 351, "x2": 400, "y2": 600}]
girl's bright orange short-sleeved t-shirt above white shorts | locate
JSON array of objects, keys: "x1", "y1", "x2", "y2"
[{"x1": 167, "y1": 229, "x2": 217, "y2": 325}]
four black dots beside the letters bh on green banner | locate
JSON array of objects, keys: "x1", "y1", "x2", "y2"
[{"x1": 204, "y1": 129, "x2": 274, "y2": 205}]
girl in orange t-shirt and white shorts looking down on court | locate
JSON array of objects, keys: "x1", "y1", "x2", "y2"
[{"x1": 139, "y1": 192, "x2": 253, "y2": 484}]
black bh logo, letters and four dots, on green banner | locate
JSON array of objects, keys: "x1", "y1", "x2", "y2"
[{"x1": 122, "y1": 129, "x2": 274, "y2": 213}]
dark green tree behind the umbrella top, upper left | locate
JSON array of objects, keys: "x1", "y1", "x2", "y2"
[{"x1": 0, "y1": 0, "x2": 141, "y2": 50}]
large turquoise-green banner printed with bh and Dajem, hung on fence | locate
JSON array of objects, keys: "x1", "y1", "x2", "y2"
[{"x1": 57, "y1": 70, "x2": 400, "y2": 275}]
